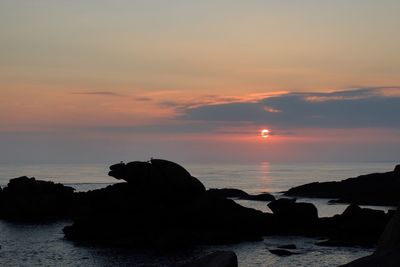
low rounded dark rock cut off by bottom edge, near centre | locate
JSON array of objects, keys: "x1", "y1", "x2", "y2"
[{"x1": 181, "y1": 251, "x2": 238, "y2": 267}]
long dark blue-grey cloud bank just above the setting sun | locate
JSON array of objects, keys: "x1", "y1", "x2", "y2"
[{"x1": 182, "y1": 87, "x2": 400, "y2": 128}]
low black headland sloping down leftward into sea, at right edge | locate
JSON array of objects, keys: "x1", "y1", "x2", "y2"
[{"x1": 285, "y1": 165, "x2": 400, "y2": 206}]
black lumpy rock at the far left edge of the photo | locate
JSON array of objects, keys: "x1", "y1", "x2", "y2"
[{"x1": 0, "y1": 176, "x2": 74, "y2": 219}]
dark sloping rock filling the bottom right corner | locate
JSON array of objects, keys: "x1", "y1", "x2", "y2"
[{"x1": 343, "y1": 206, "x2": 400, "y2": 267}]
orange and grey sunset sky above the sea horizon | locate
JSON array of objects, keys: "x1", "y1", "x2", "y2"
[{"x1": 0, "y1": 0, "x2": 400, "y2": 163}]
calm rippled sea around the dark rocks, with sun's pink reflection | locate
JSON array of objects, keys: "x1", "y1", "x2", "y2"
[{"x1": 0, "y1": 162, "x2": 396, "y2": 267}]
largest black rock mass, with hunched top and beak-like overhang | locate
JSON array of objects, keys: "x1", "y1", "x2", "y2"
[{"x1": 64, "y1": 160, "x2": 272, "y2": 247}]
